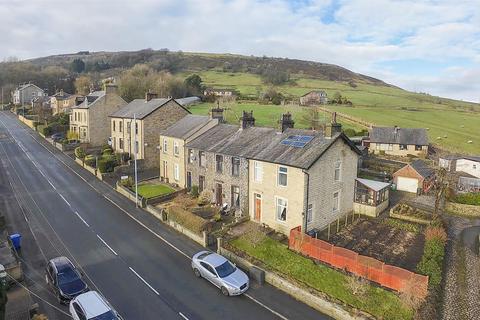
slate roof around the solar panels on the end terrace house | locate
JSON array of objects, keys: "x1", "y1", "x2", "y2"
[{"x1": 251, "y1": 129, "x2": 360, "y2": 169}]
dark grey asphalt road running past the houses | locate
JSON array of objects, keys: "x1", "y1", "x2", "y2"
[{"x1": 0, "y1": 112, "x2": 329, "y2": 319}]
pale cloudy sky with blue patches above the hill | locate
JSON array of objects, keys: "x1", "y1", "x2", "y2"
[{"x1": 0, "y1": 0, "x2": 480, "y2": 102}]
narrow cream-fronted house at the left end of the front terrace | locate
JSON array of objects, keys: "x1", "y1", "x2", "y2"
[{"x1": 160, "y1": 114, "x2": 218, "y2": 190}]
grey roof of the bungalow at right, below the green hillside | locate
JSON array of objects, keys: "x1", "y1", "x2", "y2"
[{"x1": 370, "y1": 127, "x2": 428, "y2": 146}]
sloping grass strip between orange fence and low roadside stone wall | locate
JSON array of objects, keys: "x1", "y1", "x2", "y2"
[{"x1": 231, "y1": 237, "x2": 413, "y2": 320}]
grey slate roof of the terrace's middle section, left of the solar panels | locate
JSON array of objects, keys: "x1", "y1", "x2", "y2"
[{"x1": 187, "y1": 124, "x2": 275, "y2": 158}]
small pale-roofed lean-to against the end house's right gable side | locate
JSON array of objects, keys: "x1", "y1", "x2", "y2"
[{"x1": 353, "y1": 178, "x2": 391, "y2": 217}]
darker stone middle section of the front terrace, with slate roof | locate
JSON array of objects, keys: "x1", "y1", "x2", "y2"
[{"x1": 187, "y1": 112, "x2": 275, "y2": 214}]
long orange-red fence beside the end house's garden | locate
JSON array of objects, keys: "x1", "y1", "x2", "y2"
[{"x1": 288, "y1": 227, "x2": 428, "y2": 298}]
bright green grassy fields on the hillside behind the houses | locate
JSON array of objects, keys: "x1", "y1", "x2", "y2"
[{"x1": 185, "y1": 70, "x2": 480, "y2": 154}]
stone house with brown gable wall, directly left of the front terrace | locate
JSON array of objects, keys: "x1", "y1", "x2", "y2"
[{"x1": 110, "y1": 92, "x2": 190, "y2": 168}]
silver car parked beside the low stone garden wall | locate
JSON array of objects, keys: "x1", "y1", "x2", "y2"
[{"x1": 192, "y1": 251, "x2": 249, "y2": 296}]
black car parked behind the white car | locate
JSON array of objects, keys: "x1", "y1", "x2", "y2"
[{"x1": 45, "y1": 257, "x2": 88, "y2": 304}]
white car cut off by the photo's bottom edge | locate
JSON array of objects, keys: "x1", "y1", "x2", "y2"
[{"x1": 70, "y1": 291, "x2": 122, "y2": 320}]
